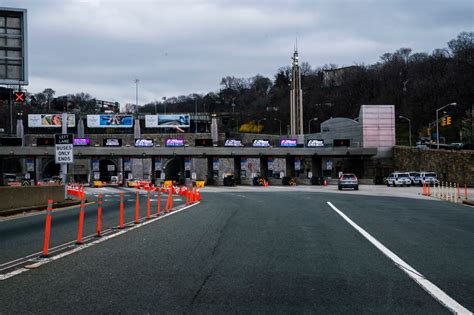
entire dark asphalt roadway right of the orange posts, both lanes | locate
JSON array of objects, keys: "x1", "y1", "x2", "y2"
[{"x1": 0, "y1": 191, "x2": 474, "y2": 314}]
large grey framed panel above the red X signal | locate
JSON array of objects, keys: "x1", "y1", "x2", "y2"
[{"x1": 0, "y1": 8, "x2": 28, "y2": 86}]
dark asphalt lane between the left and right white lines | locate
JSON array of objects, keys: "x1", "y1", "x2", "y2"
[{"x1": 0, "y1": 192, "x2": 462, "y2": 314}]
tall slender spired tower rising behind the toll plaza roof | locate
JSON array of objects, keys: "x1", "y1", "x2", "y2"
[{"x1": 290, "y1": 42, "x2": 303, "y2": 136}]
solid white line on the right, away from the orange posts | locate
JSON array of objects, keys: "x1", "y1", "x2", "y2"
[{"x1": 327, "y1": 201, "x2": 472, "y2": 314}]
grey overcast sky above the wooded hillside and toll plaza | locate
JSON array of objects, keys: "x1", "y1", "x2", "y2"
[{"x1": 0, "y1": 0, "x2": 474, "y2": 105}]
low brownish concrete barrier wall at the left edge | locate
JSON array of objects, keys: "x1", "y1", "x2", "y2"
[{"x1": 0, "y1": 185, "x2": 64, "y2": 212}]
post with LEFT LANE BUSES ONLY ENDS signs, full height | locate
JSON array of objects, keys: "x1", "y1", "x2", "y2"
[{"x1": 54, "y1": 113, "x2": 74, "y2": 199}]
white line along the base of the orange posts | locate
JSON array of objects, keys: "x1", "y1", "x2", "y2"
[{"x1": 0, "y1": 201, "x2": 200, "y2": 281}]
